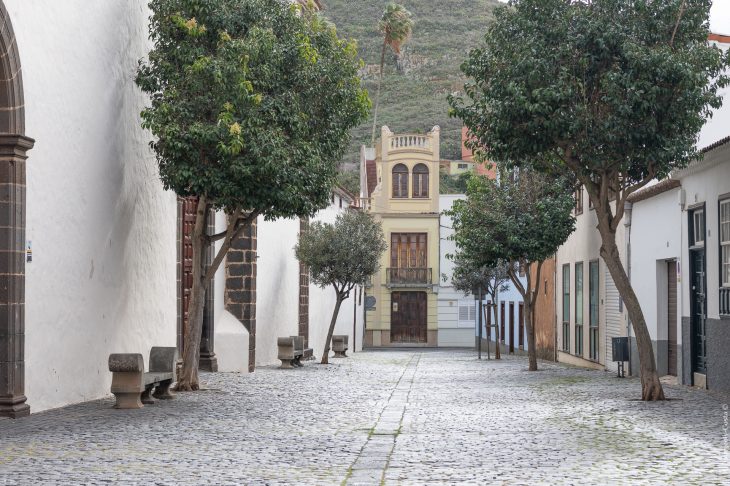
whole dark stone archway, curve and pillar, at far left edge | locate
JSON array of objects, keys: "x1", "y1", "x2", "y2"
[{"x1": 0, "y1": 0, "x2": 34, "y2": 418}]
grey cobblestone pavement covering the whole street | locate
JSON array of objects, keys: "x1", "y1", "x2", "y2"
[{"x1": 0, "y1": 350, "x2": 730, "y2": 485}]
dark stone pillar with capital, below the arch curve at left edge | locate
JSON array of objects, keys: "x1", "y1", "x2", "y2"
[{"x1": 0, "y1": 134, "x2": 34, "y2": 418}]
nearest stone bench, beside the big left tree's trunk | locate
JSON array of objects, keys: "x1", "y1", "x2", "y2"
[{"x1": 109, "y1": 346, "x2": 177, "y2": 409}]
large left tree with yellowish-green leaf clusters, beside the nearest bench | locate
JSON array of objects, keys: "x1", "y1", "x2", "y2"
[{"x1": 136, "y1": 0, "x2": 369, "y2": 390}]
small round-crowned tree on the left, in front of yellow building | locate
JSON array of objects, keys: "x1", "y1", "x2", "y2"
[{"x1": 294, "y1": 209, "x2": 387, "y2": 364}]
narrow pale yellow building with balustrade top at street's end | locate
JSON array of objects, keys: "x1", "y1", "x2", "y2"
[{"x1": 361, "y1": 126, "x2": 440, "y2": 347}]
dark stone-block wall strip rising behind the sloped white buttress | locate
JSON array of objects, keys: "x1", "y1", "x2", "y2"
[{"x1": 225, "y1": 221, "x2": 256, "y2": 372}]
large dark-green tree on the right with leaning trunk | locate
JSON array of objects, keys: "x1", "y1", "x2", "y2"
[{"x1": 450, "y1": 0, "x2": 730, "y2": 400}]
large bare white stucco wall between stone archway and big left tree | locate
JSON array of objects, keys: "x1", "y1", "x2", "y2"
[{"x1": 11, "y1": 0, "x2": 176, "y2": 412}]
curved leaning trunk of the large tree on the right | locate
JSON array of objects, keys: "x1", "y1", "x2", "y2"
[{"x1": 598, "y1": 224, "x2": 664, "y2": 401}]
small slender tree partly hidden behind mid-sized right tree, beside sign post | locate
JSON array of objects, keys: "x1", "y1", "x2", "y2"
[{"x1": 447, "y1": 252, "x2": 510, "y2": 359}]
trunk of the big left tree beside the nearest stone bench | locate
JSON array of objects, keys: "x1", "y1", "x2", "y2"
[{"x1": 177, "y1": 195, "x2": 208, "y2": 391}]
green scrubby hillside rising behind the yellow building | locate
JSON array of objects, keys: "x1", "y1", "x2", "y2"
[{"x1": 323, "y1": 0, "x2": 497, "y2": 175}]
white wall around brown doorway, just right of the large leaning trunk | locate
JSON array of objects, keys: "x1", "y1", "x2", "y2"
[{"x1": 631, "y1": 188, "x2": 682, "y2": 343}]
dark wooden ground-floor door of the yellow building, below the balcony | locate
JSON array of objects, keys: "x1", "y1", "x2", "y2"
[{"x1": 390, "y1": 292, "x2": 427, "y2": 344}]
